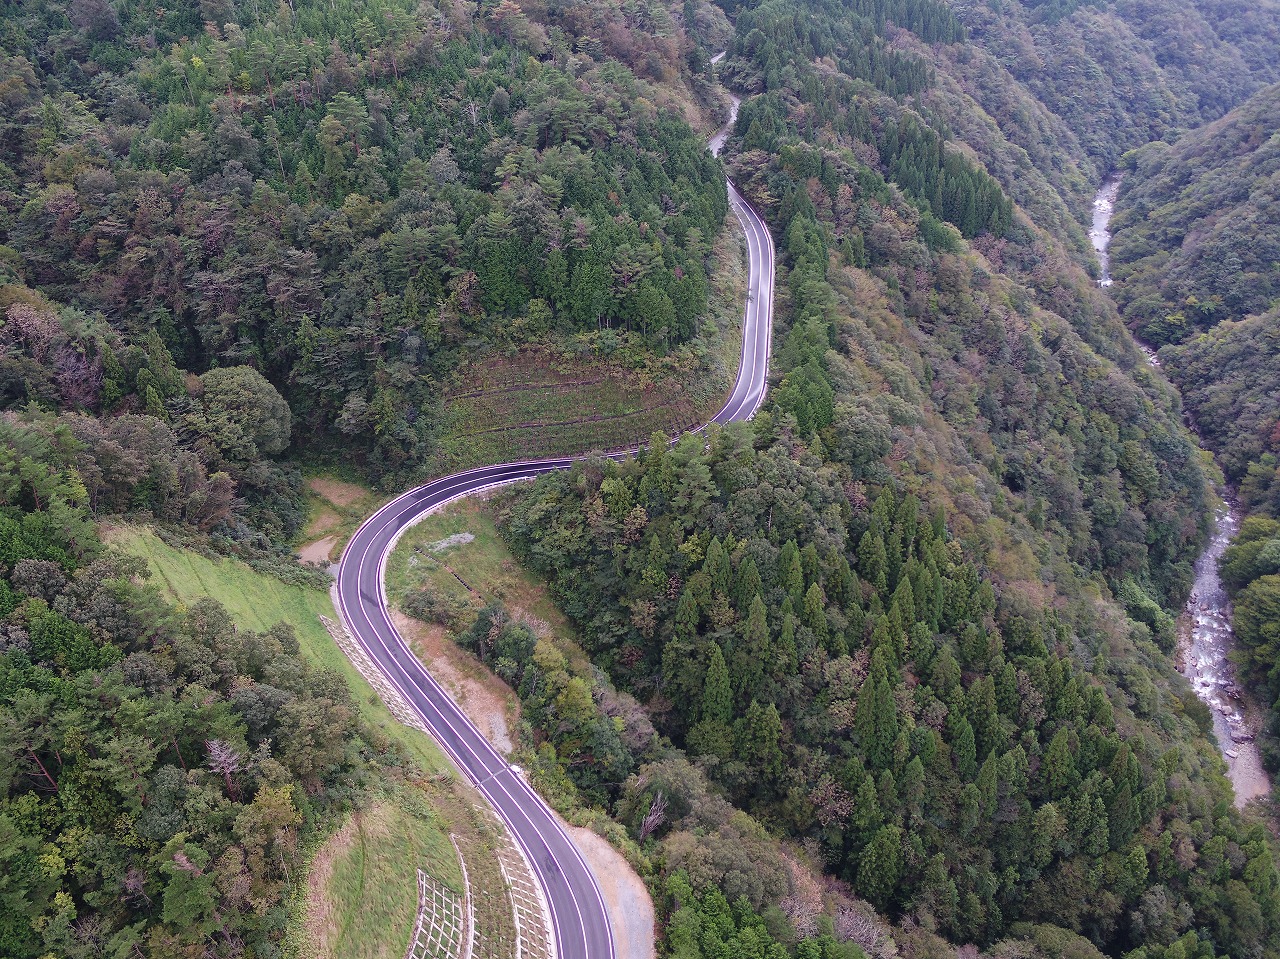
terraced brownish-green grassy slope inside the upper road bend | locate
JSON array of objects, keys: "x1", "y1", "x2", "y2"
[{"x1": 431, "y1": 214, "x2": 748, "y2": 474}]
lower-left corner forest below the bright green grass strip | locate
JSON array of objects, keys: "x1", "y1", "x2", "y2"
[{"x1": 0, "y1": 414, "x2": 381, "y2": 959}]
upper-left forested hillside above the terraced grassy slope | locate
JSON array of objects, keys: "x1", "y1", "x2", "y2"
[{"x1": 0, "y1": 0, "x2": 726, "y2": 474}]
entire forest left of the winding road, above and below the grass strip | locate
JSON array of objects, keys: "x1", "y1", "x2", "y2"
[{"x1": 0, "y1": 0, "x2": 742, "y2": 956}]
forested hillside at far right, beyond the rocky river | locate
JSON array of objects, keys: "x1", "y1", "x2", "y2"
[{"x1": 1112, "y1": 86, "x2": 1280, "y2": 772}]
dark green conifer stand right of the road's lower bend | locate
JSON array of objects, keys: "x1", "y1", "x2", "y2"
[{"x1": 501, "y1": 437, "x2": 1280, "y2": 955}]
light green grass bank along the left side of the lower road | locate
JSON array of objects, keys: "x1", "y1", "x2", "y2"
[{"x1": 112, "y1": 517, "x2": 542, "y2": 959}]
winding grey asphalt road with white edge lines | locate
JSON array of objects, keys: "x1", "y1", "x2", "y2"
[{"x1": 338, "y1": 74, "x2": 774, "y2": 959}]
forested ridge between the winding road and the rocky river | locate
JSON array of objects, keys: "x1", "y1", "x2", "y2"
[{"x1": 486, "y1": 0, "x2": 1280, "y2": 956}]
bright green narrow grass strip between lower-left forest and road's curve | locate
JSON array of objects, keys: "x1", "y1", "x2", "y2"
[{"x1": 104, "y1": 526, "x2": 448, "y2": 772}]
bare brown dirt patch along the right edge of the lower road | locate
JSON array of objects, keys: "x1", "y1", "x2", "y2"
[{"x1": 392, "y1": 611, "x2": 520, "y2": 757}]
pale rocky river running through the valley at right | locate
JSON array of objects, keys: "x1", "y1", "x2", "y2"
[{"x1": 1089, "y1": 174, "x2": 1271, "y2": 805}]
